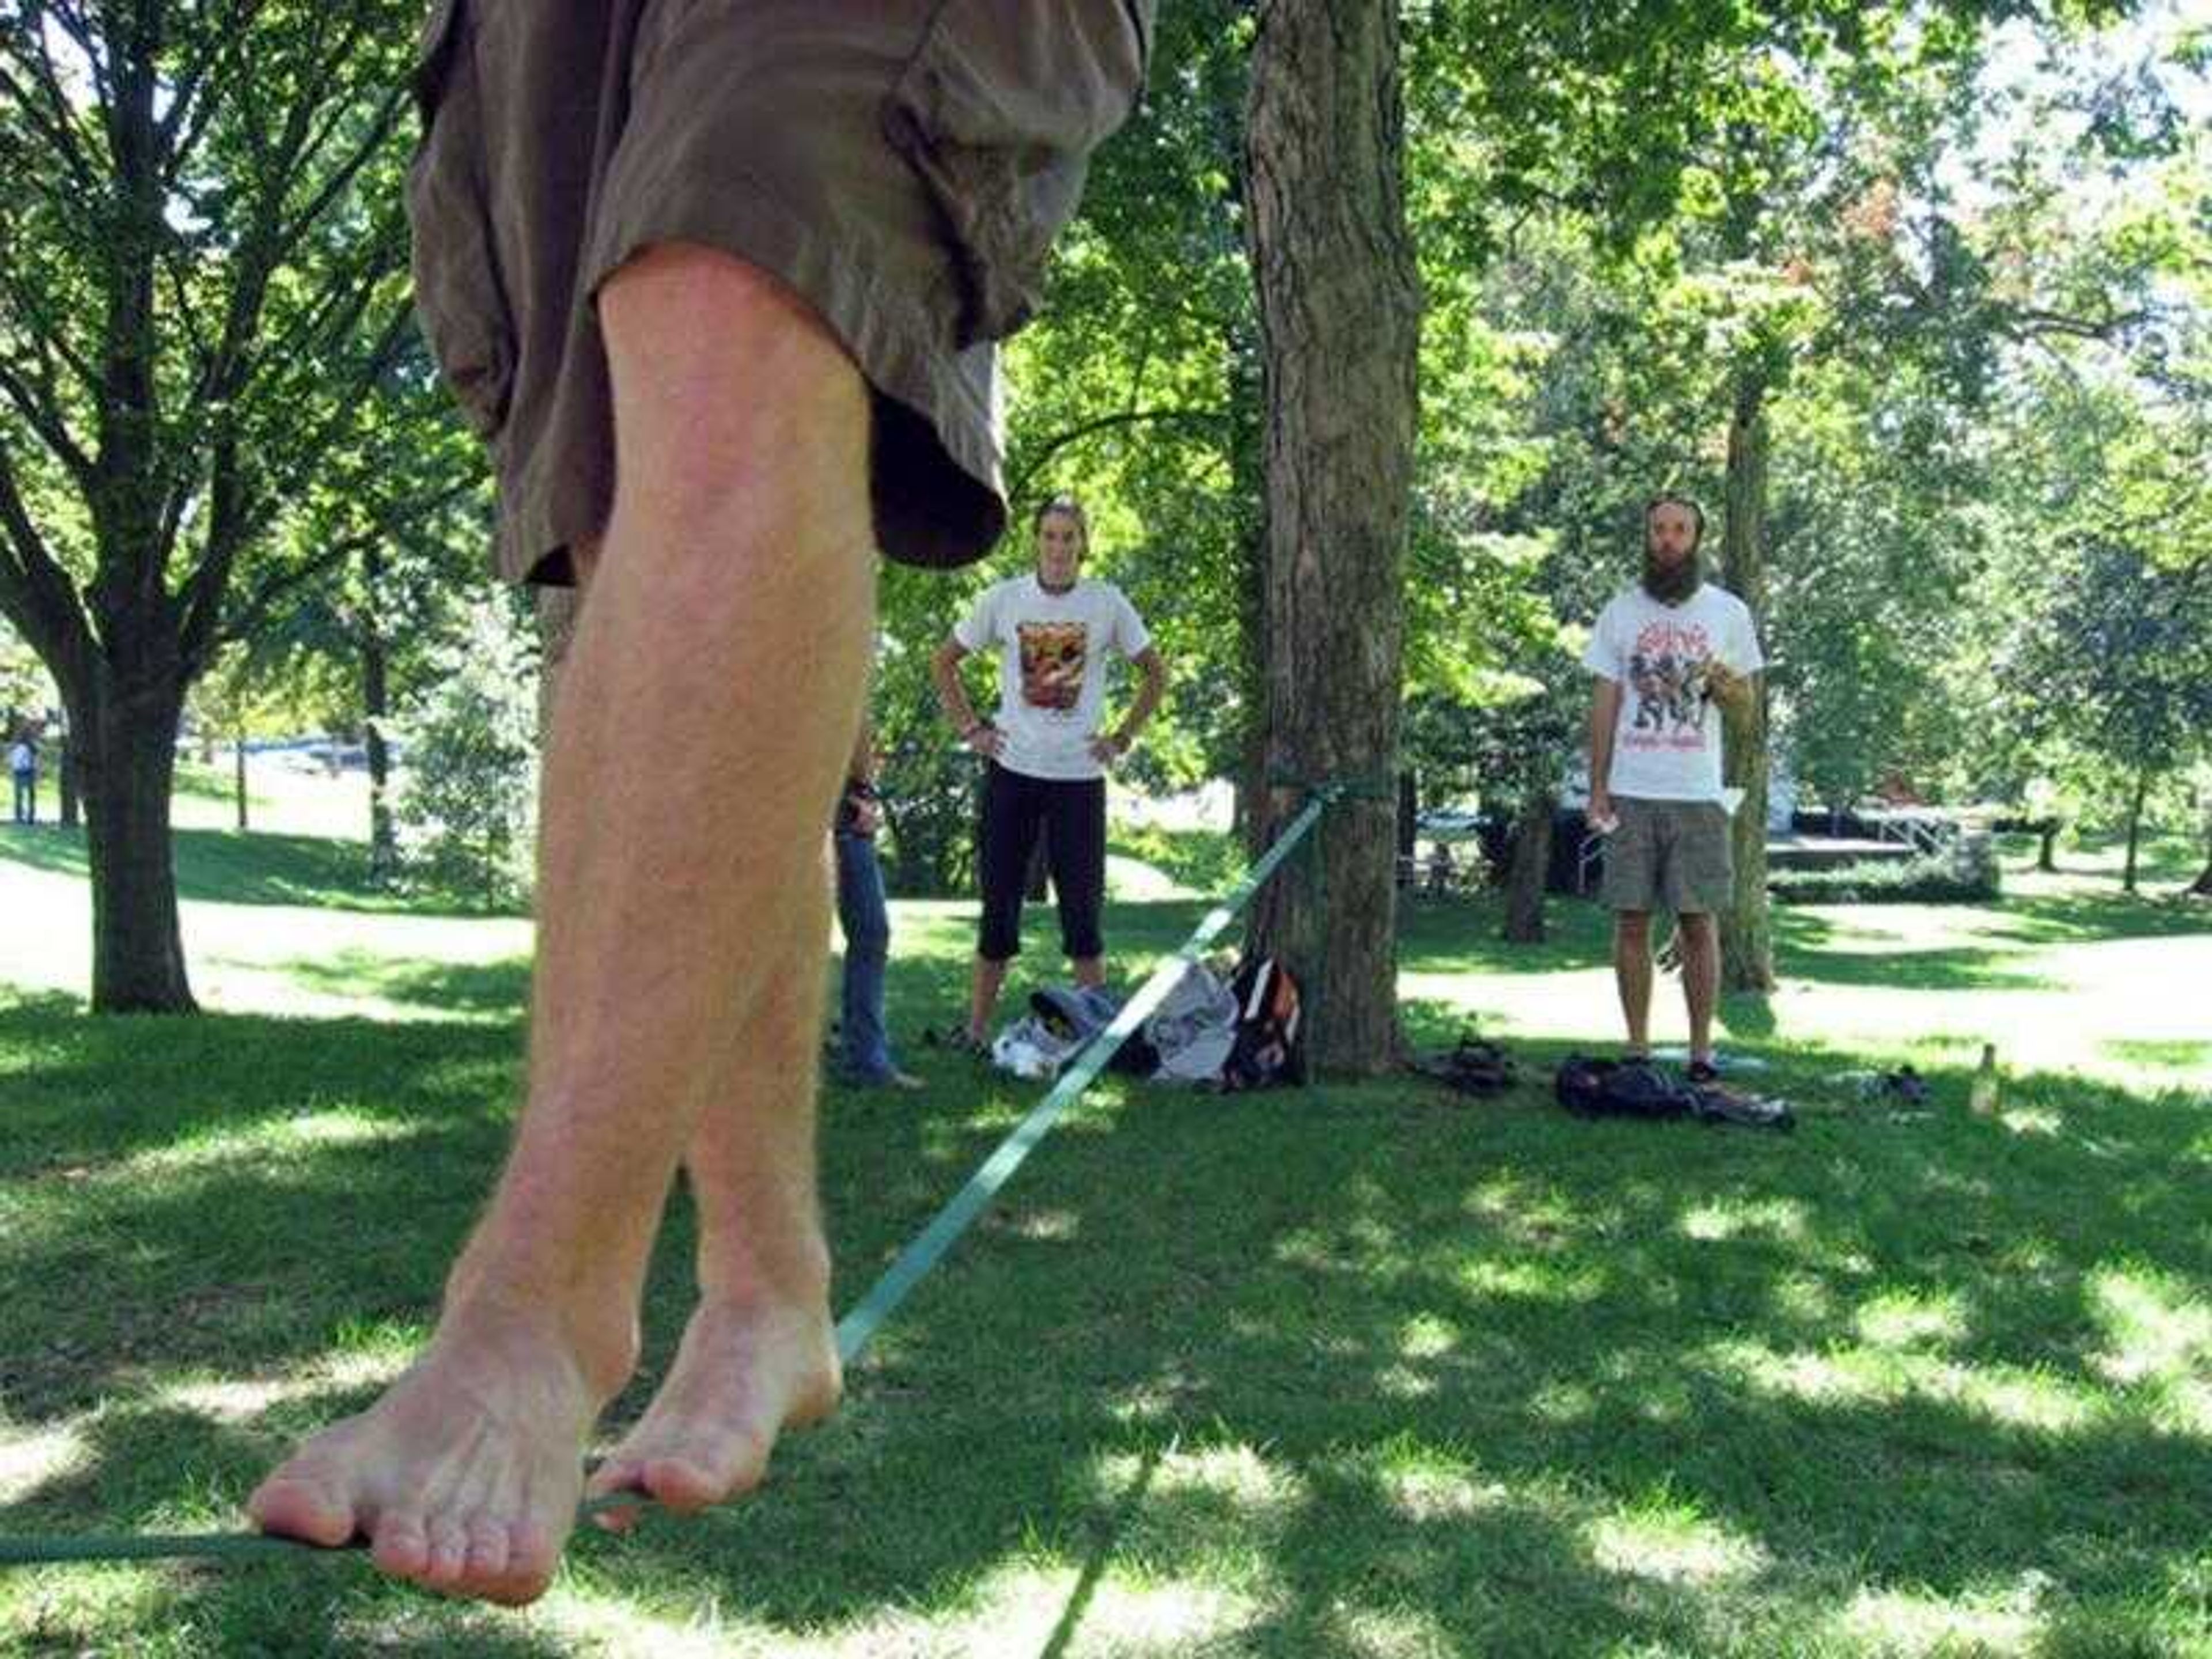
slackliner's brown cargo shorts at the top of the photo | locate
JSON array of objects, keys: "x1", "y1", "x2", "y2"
[{"x1": 407, "y1": 0, "x2": 1154, "y2": 582}]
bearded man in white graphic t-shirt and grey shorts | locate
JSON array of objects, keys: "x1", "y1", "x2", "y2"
[{"x1": 1582, "y1": 495, "x2": 1765, "y2": 1082}]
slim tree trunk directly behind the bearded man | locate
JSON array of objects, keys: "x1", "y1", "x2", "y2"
[{"x1": 1721, "y1": 374, "x2": 1774, "y2": 991}]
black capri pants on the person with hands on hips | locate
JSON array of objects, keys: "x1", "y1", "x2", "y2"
[{"x1": 975, "y1": 761, "x2": 1106, "y2": 962}]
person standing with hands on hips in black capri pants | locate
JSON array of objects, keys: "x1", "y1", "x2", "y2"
[{"x1": 931, "y1": 495, "x2": 1168, "y2": 1051}]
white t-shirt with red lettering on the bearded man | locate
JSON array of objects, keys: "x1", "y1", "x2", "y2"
[{"x1": 1582, "y1": 582, "x2": 1765, "y2": 801}]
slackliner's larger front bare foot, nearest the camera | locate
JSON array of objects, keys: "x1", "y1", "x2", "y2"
[{"x1": 248, "y1": 1312, "x2": 601, "y2": 1604}]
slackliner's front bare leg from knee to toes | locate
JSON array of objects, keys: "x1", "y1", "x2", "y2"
[{"x1": 252, "y1": 248, "x2": 874, "y2": 1601}]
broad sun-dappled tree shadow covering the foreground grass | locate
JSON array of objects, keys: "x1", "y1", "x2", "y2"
[{"x1": 0, "y1": 1011, "x2": 2212, "y2": 1657}]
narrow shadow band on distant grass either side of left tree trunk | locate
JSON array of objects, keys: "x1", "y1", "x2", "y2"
[{"x1": 0, "y1": 827, "x2": 527, "y2": 916}]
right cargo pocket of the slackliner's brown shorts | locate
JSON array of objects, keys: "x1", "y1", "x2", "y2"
[{"x1": 882, "y1": 0, "x2": 1150, "y2": 347}]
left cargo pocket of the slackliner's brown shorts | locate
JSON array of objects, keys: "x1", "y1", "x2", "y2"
[{"x1": 407, "y1": 0, "x2": 516, "y2": 438}]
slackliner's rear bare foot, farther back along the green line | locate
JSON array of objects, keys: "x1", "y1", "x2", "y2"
[{"x1": 588, "y1": 1301, "x2": 845, "y2": 1531}]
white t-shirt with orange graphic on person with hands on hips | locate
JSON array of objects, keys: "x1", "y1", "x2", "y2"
[{"x1": 953, "y1": 573, "x2": 1153, "y2": 779}]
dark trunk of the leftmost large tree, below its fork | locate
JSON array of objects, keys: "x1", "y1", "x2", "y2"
[{"x1": 71, "y1": 661, "x2": 197, "y2": 1013}]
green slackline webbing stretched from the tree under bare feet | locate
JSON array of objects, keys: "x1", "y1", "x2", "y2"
[{"x1": 0, "y1": 781, "x2": 1358, "y2": 1569}]
